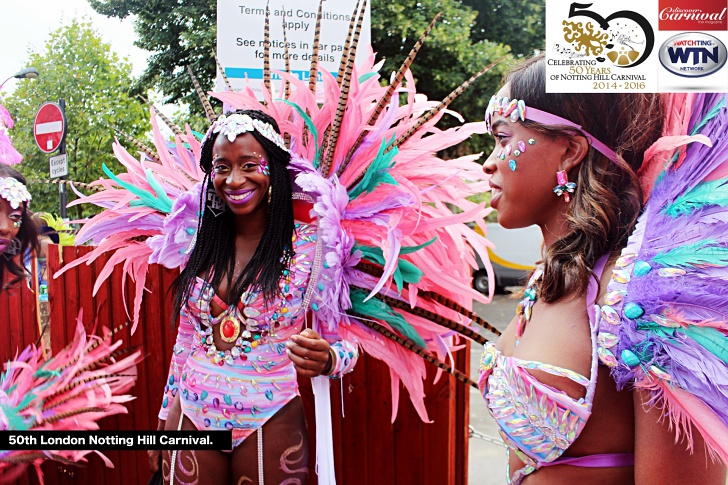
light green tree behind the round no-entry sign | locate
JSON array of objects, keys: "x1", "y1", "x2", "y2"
[{"x1": 3, "y1": 19, "x2": 150, "y2": 217}]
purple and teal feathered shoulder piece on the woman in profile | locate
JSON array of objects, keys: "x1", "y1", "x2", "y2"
[{"x1": 598, "y1": 94, "x2": 728, "y2": 463}]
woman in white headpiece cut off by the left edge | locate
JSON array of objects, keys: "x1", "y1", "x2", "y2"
[{"x1": 0, "y1": 164, "x2": 39, "y2": 289}]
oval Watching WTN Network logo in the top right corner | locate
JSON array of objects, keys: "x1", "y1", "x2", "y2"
[{"x1": 659, "y1": 32, "x2": 726, "y2": 77}]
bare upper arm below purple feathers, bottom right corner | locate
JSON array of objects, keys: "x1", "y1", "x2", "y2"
[{"x1": 634, "y1": 390, "x2": 726, "y2": 485}]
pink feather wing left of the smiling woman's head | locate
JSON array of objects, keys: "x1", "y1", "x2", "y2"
[{"x1": 54, "y1": 113, "x2": 203, "y2": 332}]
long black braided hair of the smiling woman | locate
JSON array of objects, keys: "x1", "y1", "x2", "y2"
[{"x1": 172, "y1": 110, "x2": 294, "y2": 322}]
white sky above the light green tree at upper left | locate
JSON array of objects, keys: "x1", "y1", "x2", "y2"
[{"x1": 0, "y1": 0, "x2": 149, "y2": 94}]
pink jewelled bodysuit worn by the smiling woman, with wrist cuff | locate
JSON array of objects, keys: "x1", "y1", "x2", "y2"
[{"x1": 159, "y1": 223, "x2": 358, "y2": 447}]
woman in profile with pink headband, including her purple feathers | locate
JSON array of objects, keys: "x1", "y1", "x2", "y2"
[{"x1": 479, "y1": 56, "x2": 728, "y2": 485}]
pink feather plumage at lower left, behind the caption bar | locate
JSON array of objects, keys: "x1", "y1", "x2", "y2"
[{"x1": 0, "y1": 316, "x2": 142, "y2": 483}]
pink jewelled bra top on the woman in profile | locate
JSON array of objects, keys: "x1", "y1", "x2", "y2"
[{"x1": 478, "y1": 257, "x2": 634, "y2": 484}]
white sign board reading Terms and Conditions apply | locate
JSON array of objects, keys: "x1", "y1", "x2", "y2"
[{"x1": 217, "y1": 0, "x2": 371, "y2": 99}]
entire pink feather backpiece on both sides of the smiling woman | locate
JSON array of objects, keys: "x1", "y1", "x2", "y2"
[{"x1": 64, "y1": 2, "x2": 497, "y2": 419}]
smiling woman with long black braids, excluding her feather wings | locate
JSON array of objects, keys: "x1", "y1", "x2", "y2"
[{"x1": 149, "y1": 110, "x2": 357, "y2": 484}]
